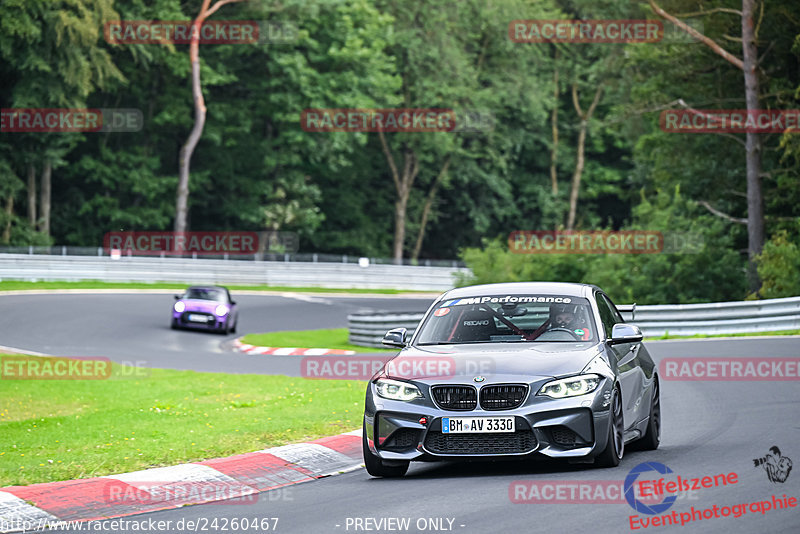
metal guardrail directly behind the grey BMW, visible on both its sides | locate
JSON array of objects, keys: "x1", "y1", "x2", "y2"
[{"x1": 347, "y1": 297, "x2": 800, "y2": 347}]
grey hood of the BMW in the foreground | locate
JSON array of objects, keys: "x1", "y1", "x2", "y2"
[{"x1": 386, "y1": 342, "x2": 600, "y2": 383}]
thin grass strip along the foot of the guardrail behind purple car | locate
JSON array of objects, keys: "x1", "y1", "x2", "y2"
[{"x1": 0, "y1": 280, "x2": 431, "y2": 295}]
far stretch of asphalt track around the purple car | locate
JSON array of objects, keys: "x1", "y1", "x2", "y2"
[{"x1": 0, "y1": 293, "x2": 433, "y2": 376}]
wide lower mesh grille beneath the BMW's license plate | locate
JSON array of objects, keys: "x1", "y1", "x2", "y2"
[{"x1": 425, "y1": 429, "x2": 536, "y2": 455}]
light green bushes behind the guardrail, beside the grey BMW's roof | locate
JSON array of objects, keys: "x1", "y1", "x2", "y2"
[{"x1": 461, "y1": 190, "x2": 744, "y2": 304}]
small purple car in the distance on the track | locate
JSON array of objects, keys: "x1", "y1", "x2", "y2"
[{"x1": 172, "y1": 286, "x2": 239, "y2": 334}]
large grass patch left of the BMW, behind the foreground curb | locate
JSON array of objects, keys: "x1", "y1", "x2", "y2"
[{"x1": 0, "y1": 356, "x2": 366, "y2": 487}]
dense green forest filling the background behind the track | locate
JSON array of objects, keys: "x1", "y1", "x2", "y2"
[{"x1": 0, "y1": 0, "x2": 800, "y2": 303}]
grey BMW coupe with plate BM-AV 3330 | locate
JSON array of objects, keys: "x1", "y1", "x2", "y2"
[{"x1": 363, "y1": 282, "x2": 661, "y2": 477}]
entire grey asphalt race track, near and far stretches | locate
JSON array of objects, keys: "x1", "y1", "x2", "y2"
[{"x1": 0, "y1": 295, "x2": 800, "y2": 534}]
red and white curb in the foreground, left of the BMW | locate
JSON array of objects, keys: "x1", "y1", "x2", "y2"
[{"x1": 0, "y1": 430, "x2": 362, "y2": 533}]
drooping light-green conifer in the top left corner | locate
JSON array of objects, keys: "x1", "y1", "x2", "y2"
[{"x1": 0, "y1": 0, "x2": 123, "y2": 241}]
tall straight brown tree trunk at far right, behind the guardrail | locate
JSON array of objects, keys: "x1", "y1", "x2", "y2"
[{"x1": 742, "y1": 0, "x2": 764, "y2": 292}]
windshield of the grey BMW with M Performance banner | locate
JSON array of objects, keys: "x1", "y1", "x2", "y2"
[{"x1": 417, "y1": 295, "x2": 597, "y2": 345}]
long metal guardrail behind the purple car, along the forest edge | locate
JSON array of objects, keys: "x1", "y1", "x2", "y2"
[{"x1": 0, "y1": 254, "x2": 466, "y2": 291}]
